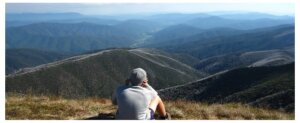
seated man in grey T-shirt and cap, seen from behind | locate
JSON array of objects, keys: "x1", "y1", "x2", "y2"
[{"x1": 112, "y1": 68, "x2": 171, "y2": 120}]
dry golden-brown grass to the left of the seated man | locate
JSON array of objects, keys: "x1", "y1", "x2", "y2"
[{"x1": 5, "y1": 95, "x2": 116, "y2": 120}]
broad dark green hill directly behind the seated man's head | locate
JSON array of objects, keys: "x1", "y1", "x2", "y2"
[{"x1": 5, "y1": 49, "x2": 204, "y2": 98}]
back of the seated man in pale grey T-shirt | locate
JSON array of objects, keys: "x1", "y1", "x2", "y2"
[{"x1": 116, "y1": 85, "x2": 157, "y2": 119}]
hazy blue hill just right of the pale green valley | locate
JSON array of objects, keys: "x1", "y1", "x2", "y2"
[{"x1": 144, "y1": 24, "x2": 241, "y2": 47}]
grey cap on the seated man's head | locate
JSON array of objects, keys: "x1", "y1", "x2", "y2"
[{"x1": 129, "y1": 68, "x2": 147, "y2": 86}]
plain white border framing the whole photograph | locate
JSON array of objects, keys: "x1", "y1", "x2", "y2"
[{"x1": 0, "y1": 0, "x2": 300, "y2": 123}]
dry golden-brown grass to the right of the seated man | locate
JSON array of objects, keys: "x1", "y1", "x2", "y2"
[{"x1": 165, "y1": 100, "x2": 295, "y2": 120}]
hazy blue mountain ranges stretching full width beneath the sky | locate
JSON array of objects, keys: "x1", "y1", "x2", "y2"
[{"x1": 6, "y1": 13, "x2": 294, "y2": 53}]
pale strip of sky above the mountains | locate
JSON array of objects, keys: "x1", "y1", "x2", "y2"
[{"x1": 5, "y1": 3, "x2": 295, "y2": 15}]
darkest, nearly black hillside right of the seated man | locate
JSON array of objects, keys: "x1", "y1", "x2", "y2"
[{"x1": 159, "y1": 63, "x2": 295, "y2": 112}]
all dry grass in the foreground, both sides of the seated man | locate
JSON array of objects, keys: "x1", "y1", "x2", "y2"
[{"x1": 5, "y1": 95, "x2": 295, "y2": 120}]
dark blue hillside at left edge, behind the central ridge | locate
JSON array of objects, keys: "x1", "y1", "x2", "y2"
[{"x1": 5, "y1": 49, "x2": 69, "y2": 75}]
